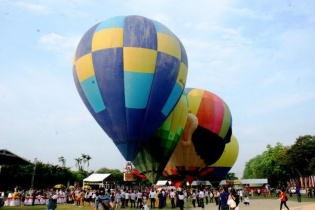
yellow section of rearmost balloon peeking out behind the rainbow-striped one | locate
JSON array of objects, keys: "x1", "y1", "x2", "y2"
[{"x1": 209, "y1": 135, "x2": 239, "y2": 167}]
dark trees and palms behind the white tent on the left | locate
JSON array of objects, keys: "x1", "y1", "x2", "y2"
[{"x1": 0, "y1": 154, "x2": 150, "y2": 192}]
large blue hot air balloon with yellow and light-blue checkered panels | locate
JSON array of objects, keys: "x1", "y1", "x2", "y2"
[{"x1": 73, "y1": 16, "x2": 188, "y2": 161}]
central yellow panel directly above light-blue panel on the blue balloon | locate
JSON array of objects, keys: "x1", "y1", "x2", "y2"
[{"x1": 123, "y1": 47, "x2": 157, "y2": 73}]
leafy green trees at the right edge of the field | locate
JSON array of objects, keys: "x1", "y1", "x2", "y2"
[{"x1": 243, "y1": 135, "x2": 315, "y2": 187}]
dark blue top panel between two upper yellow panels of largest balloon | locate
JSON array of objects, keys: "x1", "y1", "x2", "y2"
[{"x1": 124, "y1": 16, "x2": 157, "y2": 50}]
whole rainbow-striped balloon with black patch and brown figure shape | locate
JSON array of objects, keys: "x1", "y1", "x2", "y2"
[{"x1": 169, "y1": 88, "x2": 232, "y2": 183}]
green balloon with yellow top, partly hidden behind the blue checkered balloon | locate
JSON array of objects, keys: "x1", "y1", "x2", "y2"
[{"x1": 132, "y1": 95, "x2": 188, "y2": 184}]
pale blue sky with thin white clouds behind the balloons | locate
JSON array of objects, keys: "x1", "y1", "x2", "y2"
[{"x1": 0, "y1": 0, "x2": 315, "y2": 177}]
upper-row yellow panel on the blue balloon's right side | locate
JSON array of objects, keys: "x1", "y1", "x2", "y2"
[{"x1": 157, "y1": 33, "x2": 181, "y2": 60}]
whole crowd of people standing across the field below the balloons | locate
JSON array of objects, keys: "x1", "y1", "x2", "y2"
[{"x1": 2, "y1": 187, "x2": 300, "y2": 210}]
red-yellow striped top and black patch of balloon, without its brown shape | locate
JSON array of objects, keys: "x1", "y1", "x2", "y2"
[{"x1": 185, "y1": 88, "x2": 232, "y2": 165}]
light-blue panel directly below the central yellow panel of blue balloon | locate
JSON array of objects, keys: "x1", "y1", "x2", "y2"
[{"x1": 124, "y1": 71, "x2": 154, "y2": 109}]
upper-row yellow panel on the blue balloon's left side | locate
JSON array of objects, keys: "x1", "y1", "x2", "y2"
[{"x1": 92, "y1": 28, "x2": 124, "y2": 52}]
